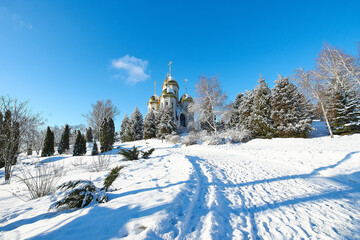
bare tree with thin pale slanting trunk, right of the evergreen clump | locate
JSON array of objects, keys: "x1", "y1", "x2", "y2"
[{"x1": 294, "y1": 68, "x2": 334, "y2": 138}]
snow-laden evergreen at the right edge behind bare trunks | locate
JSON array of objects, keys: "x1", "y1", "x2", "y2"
[{"x1": 327, "y1": 82, "x2": 360, "y2": 134}]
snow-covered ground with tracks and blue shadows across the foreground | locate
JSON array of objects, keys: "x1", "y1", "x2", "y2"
[{"x1": 0, "y1": 134, "x2": 360, "y2": 240}]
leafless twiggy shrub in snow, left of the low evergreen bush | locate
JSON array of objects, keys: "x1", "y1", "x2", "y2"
[{"x1": 19, "y1": 163, "x2": 65, "y2": 199}]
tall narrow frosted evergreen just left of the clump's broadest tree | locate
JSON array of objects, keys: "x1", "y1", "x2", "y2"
[{"x1": 250, "y1": 77, "x2": 273, "y2": 138}]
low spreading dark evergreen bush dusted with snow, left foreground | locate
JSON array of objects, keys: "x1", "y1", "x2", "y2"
[{"x1": 51, "y1": 180, "x2": 108, "y2": 209}]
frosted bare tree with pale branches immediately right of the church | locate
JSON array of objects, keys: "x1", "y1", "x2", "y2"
[{"x1": 190, "y1": 76, "x2": 227, "y2": 134}]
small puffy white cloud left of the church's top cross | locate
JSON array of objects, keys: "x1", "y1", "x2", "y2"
[{"x1": 111, "y1": 55, "x2": 150, "y2": 84}]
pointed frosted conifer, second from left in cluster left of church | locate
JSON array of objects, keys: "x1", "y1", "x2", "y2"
[{"x1": 125, "y1": 107, "x2": 144, "y2": 141}]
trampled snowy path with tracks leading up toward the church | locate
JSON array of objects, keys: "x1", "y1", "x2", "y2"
[{"x1": 169, "y1": 143, "x2": 360, "y2": 239}]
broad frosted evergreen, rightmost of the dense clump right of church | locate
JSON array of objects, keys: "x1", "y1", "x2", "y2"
[{"x1": 271, "y1": 76, "x2": 312, "y2": 137}]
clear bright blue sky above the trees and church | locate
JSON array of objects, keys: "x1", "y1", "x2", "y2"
[{"x1": 0, "y1": 0, "x2": 360, "y2": 129}]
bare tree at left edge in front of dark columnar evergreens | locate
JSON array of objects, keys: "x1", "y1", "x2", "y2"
[{"x1": 0, "y1": 96, "x2": 43, "y2": 183}]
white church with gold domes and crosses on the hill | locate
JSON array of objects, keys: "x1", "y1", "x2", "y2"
[{"x1": 147, "y1": 62, "x2": 194, "y2": 129}]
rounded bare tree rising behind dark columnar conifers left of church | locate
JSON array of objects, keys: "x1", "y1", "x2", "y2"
[{"x1": 83, "y1": 99, "x2": 120, "y2": 139}]
